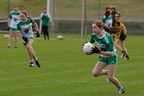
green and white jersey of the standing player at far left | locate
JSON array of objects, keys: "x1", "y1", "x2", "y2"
[{"x1": 9, "y1": 11, "x2": 20, "y2": 28}]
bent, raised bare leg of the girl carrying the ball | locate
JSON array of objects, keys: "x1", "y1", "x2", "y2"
[{"x1": 92, "y1": 61, "x2": 107, "y2": 77}]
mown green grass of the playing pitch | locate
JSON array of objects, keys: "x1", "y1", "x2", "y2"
[{"x1": 0, "y1": 34, "x2": 144, "y2": 96}]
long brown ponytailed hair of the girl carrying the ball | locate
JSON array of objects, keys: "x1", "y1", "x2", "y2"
[{"x1": 93, "y1": 20, "x2": 122, "y2": 34}]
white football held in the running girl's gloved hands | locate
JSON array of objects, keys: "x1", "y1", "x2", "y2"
[{"x1": 82, "y1": 42, "x2": 94, "y2": 55}]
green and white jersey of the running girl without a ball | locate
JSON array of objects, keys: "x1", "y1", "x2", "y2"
[{"x1": 17, "y1": 18, "x2": 36, "y2": 38}]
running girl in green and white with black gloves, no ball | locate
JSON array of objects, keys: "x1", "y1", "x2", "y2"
[{"x1": 17, "y1": 11, "x2": 40, "y2": 67}]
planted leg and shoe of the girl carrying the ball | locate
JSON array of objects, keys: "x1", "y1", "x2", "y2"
[{"x1": 108, "y1": 64, "x2": 125, "y2": 94}]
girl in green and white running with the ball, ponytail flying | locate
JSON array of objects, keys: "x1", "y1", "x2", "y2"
[{"x1": 89, "y1": 21, "x2": 125, "y2": 94}]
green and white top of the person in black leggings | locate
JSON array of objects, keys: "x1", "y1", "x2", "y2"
[{"x1": 41, "y1": 13, "x2": 50, "y2": 26}]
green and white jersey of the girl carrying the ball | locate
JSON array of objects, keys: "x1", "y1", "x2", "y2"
[{"x1": 89, "y1": 33, "x2": 116, "y2": 58}]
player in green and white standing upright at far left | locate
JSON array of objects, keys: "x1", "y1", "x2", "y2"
[{"x1": 8, "y1": 6, "x2": 20, "y2": 48}]
